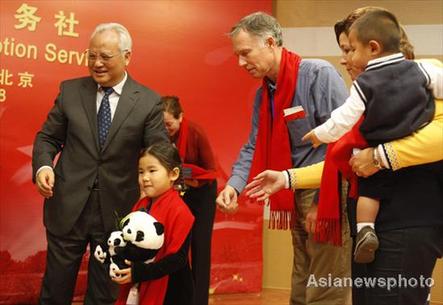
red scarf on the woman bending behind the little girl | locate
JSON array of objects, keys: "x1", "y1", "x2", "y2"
[{"x1": 176, "y1": 117, "x2": 218, "y2": 180}]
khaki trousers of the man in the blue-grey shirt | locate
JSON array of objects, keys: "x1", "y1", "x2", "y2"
[{"x1": 290, "y1": 189, "x2": 352, "y2": 305}]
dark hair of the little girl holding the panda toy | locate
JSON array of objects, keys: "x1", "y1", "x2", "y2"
[{"x1": 139, "y1": 142, "x2": 183, "y2": 184}]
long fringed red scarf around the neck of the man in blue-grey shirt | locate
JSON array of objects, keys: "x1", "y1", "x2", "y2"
[{"x1": 249, "y1": 48, "x2": 301, "y2": 229}]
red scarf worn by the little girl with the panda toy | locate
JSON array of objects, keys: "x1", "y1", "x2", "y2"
[{"x1": 115, "y1": 189, "x2": 194, "y2": 305}]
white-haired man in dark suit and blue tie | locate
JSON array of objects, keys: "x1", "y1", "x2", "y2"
[{"x1": 32, "y1": 23, "x2": 168, "y2": 305}]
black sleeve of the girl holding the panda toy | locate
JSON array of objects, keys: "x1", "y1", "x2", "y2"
[{"x1": 131, "y1": 233, "x2": 191, "y2": 283}]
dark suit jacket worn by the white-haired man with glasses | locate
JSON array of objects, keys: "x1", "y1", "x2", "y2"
[{"x1": 32, "y1": 75, "x2": 169, "y2": 236}]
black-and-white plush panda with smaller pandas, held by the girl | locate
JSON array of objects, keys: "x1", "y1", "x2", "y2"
[{"x1": 94, "y1": 210, "x2": 164, "y2": 278}]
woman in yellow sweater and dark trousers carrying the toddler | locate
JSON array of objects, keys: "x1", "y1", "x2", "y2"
[{"x1": 334, "y1": 7, "x2": 443, "y2": 305}]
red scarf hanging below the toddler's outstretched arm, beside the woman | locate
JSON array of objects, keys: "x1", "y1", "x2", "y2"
[{"x1": 314, "y1": 116, "x2": 368, "y2": 246}]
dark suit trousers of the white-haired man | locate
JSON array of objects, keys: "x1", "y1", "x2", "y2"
[{"x1": 39, "y1": 191, "x2": 118, "y2": 305}]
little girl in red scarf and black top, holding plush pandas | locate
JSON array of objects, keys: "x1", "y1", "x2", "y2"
[{"x1": 114, "y1": 143, "x2": 194, "y2": 305}]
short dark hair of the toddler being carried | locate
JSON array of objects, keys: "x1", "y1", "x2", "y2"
[{"x1": 349, "y1": 10, "x2": 401, "y2": 53}]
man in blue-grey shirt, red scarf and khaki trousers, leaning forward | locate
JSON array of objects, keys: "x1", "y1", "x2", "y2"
[{"x1": 217, "y1": 12, "x2": 350, "y2": 305}]
